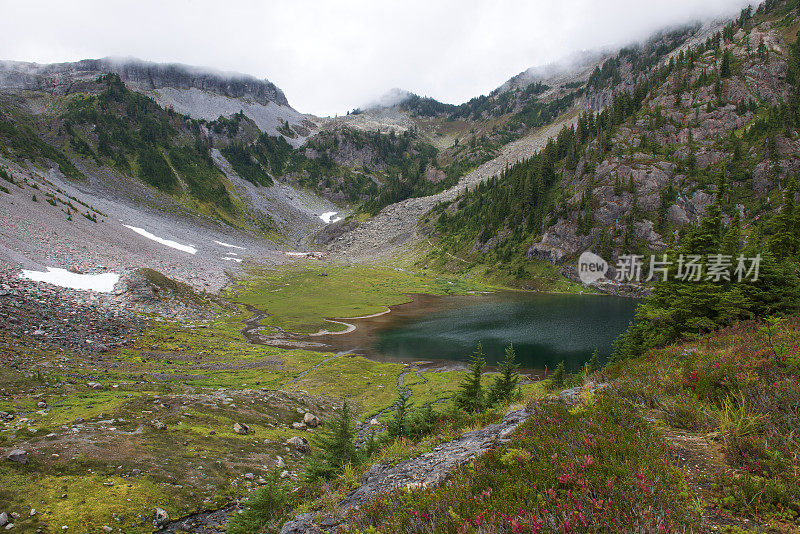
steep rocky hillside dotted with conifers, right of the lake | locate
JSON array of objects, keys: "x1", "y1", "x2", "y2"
[{"x1": 418, "y1": 5, "x2": 797, "y2": 284}]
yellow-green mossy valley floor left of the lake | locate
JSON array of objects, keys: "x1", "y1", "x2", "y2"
[{"x1": 0, "y1": 261, "x2": 510, "y2": 532}]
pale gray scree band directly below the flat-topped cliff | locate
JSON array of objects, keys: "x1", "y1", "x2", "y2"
[{"x1": 150, "y1": 87, "x2": 314, "y2": 147}]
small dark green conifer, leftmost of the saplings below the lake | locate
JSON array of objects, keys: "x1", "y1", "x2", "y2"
[{"x1": 306, "y1": 399, "x2": 359, "y2": 480}]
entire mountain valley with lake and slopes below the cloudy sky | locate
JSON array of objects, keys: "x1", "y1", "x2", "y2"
[{"x1": 0, "y1": 0, "x2": 800, "y2": 534}]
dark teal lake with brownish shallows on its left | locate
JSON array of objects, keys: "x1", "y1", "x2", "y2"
[{"x1": 367, "y1": 292, "x2": 638, "y2": 372}]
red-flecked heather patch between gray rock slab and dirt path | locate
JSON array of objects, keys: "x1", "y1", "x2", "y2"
[{"x1": 353, "y1": 396, "x2": 697, "y2": 534}]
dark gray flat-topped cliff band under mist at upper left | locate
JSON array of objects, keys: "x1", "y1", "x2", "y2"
[{"x1": 0, "y1": 58, "x2": 289, "y2": 107}]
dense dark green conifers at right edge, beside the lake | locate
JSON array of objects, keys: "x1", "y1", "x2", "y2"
[{"x1": 613, "y1": 184, "x2": 800, "y2": 360}]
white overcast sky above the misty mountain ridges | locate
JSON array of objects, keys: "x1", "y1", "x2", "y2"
[{"x1": 0, "y1": 0, "x2": 748, "y2": 115}]
